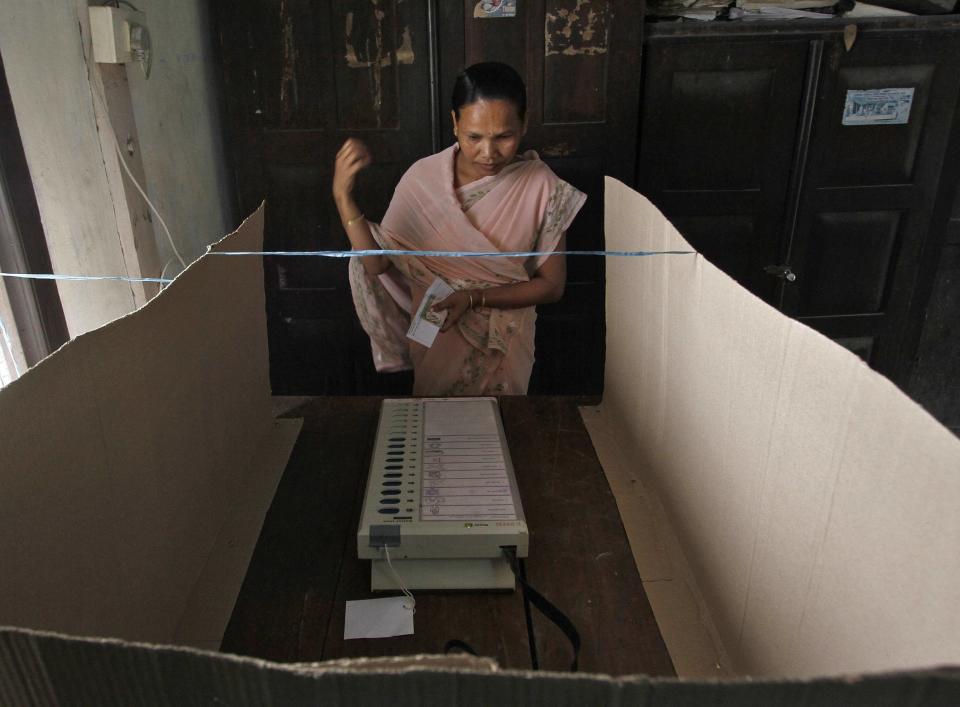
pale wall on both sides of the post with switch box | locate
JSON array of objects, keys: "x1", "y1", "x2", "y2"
[{"x1": 0, "y1": 0, "x2": 233, "y2": 336}]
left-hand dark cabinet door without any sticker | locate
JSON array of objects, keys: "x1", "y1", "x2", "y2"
[{"x1": 637, "y1": 37, "x2": 808, "y2": 302}]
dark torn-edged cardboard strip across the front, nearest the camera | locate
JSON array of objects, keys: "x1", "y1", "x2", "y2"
[{"x1": 0, "y1": 628, "x2": 960, "y2": 707}]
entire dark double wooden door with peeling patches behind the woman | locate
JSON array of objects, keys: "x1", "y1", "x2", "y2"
[{"x1": 215, "y1": 0, "x2": 642, "y2": 394}]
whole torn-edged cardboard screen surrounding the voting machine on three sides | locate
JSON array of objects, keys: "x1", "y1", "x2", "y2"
[{"x1": 0, "y1": 180, "x2": 960, "y2": 705}]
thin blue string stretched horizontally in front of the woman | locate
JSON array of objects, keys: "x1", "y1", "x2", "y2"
[{"x1": 0, "y1": 250, "x2": 696, "y2": 285}]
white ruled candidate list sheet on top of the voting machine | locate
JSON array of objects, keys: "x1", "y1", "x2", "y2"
[{"x1": 420, "y1": 400, "x2": 517, "y2": 521}]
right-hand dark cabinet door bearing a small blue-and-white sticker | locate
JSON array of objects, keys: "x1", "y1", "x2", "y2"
[{"x1": 783, "y1": 32, "x2": 960, "y2": 380}]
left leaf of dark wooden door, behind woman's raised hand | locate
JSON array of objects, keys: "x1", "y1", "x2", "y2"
[{"x1": 215, "y1": 0, "x2": 435, "y2": 394}]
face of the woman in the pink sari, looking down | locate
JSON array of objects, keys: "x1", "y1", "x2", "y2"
[{"x1": 450, "y1": 98, "x2": 527, "y2": 180}]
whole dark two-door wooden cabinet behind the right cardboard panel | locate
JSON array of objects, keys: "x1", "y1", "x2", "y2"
[{"x1": 637, "y1": 18, "x2": 960, "y2": 382}]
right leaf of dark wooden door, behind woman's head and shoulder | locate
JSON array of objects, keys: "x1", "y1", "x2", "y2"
[{"x1": 437, "y1": 0, "x2": 643, "y2": 394}]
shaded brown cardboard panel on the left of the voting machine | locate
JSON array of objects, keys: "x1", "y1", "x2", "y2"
[{"x1": 0, "y1": 203, "x2": 282, "y2": 642}]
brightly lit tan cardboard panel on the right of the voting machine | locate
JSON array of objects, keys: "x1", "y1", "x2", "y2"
[{"x1": 602, "y1": 179, "x2": 960, "y2": 676}]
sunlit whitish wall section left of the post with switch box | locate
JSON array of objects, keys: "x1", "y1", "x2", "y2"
[{"x1": 0, "y1": 0, "x2": 134, "y2": 336}]
